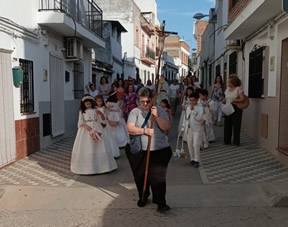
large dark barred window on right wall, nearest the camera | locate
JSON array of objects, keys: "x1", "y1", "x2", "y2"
[{"x1": 248, "y1": 47, "x2": 264, "y2": 98}]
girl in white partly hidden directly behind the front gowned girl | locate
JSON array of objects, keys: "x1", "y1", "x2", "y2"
[{"x1": 95, "y1": 95, "x2": 120, "y2": 158}]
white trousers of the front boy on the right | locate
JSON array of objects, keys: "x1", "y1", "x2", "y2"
[{"x1": 187, "y1": 128, "x2": 203, "y2": 162}]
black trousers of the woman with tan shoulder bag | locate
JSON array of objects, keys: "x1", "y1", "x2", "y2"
[{"x1": 224, "y1": 104, "x2": 243, "y2": 146}]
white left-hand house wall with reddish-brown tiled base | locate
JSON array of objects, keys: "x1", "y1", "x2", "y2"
[{"x1": 0, "y1": 0, "x2": 91, "y2": 159}]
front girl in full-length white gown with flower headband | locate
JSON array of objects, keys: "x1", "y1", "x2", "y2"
[{"x1": 71, "y1": 95, "x2": 117, "y2": 175}]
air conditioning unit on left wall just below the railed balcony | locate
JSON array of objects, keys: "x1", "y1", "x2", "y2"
[{"x1": 66, "y1": 38, "x2": 83, "y2": 60}]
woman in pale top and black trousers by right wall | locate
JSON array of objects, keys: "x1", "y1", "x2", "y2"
[{"x1": 224, "y1": 74, "x2": 245, "y2": 146}]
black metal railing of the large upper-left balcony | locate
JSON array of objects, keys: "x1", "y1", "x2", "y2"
[{"x1": 39, "y1": 0, "x2": 103, "y2": 37}]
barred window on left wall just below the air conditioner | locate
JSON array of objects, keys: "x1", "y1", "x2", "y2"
[{"x1": 73, "y1": 63, "x2": 84, "y2": 99}]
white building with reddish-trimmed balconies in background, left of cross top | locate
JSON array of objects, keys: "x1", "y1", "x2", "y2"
[{"x1": 96, "y1": 0, "x2": 158, "y2": 84}]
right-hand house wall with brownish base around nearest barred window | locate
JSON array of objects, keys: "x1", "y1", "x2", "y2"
[{"x1": 242, "y1": 18, "x2": 288, "y2": 158}]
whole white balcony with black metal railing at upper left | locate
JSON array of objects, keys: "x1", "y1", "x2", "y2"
[{"x1": 37, "y1": 0, "x2": 105, "y2": 47}]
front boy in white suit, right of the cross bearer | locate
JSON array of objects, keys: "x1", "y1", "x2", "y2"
[{"x1": 181, "y1": 93, "x2": 204, "y2": 168}]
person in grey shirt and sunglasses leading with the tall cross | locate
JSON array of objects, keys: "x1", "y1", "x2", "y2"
[{"x1": 125, "y1": 88, "x2": 172, "y2": 212}]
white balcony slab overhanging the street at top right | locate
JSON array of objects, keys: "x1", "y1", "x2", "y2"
[{"x1": 225, "y1": 0, "x2": 282, "y2": 40}]
